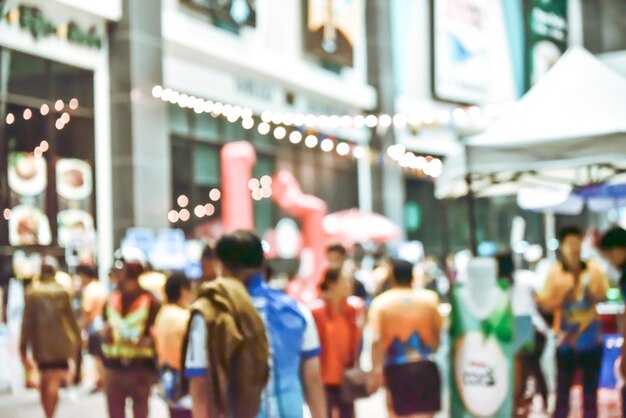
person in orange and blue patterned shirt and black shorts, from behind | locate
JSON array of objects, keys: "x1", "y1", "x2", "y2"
[{"x1": 368, "y1": 260, "x2": 443, "y2": 417}]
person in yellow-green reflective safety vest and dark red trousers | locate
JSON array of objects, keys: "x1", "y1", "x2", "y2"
[{"x1": 102, "y1": 248, "x2": 160, "y2": 418}]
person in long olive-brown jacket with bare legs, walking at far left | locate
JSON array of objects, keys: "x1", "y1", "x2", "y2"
[{"x1": 20, "y1": 260, "x2": 81, "y2": 418}]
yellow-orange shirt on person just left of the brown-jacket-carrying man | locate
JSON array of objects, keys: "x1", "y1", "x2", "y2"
[{"x1": 152, "y1": 304, "x2": 190, "y2": 370}]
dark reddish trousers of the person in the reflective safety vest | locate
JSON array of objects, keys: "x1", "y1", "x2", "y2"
[{"x1": 104, "y1": 368, "x2": 155, "y2": 418}]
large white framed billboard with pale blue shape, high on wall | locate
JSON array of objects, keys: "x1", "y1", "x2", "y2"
[{"x1": 431, "y1": 0, "x2": 490, "y2": 104}]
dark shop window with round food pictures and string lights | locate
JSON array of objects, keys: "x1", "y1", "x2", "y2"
[{"x1": 0, "y1": 49, "x2": 96, "y2": 288}]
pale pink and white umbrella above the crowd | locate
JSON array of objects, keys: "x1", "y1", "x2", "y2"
[{"x1": 323, "y1": 209, "x2": 402, "y2": 245}]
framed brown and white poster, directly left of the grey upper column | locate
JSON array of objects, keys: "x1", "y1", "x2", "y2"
[{"x1": 306, "y1": 0, "x2": 363, "y2": 67}]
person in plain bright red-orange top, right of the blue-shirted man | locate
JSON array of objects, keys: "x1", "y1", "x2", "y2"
[{"x1": 311, "y1": 269, "x2": 365, "y2": 418}]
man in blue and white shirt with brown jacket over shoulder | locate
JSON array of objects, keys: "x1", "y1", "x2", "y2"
[{"x1": 185, "y1": 231, "x2": 326, "y2": 418}]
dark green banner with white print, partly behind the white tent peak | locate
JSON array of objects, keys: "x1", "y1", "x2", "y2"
[{"x1": 524, "y1": 0, "x2": 568, "y2": 91}]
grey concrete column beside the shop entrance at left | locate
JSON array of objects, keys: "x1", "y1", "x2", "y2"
[{"x1": 110, "y1": 0, "x2": 171, "y2": 245}]
